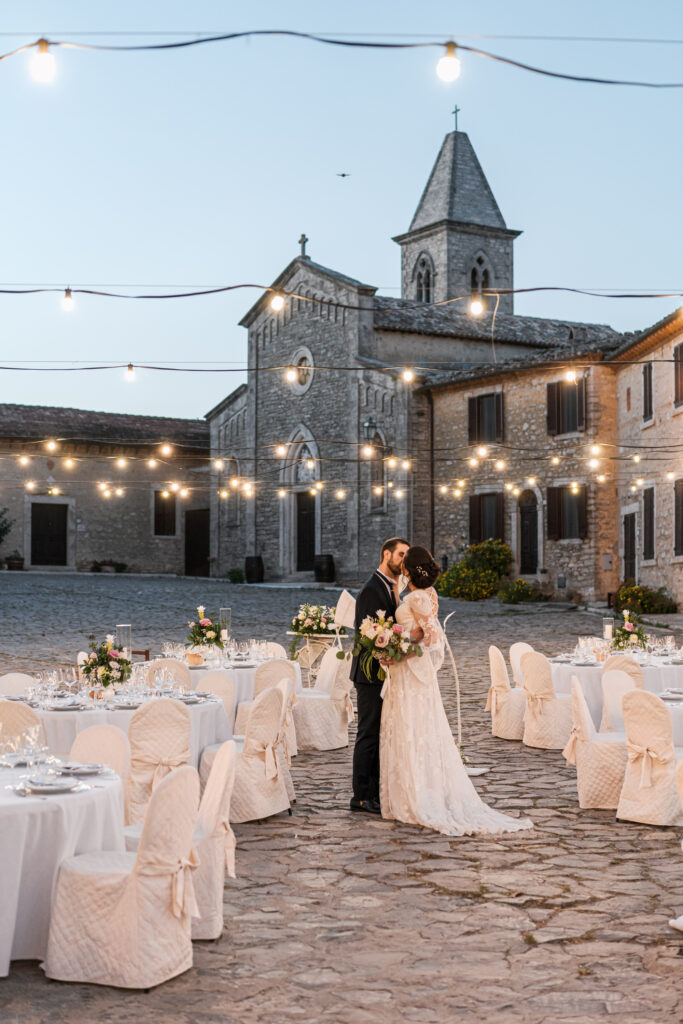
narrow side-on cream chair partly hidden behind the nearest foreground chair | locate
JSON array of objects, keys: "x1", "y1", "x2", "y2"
[{"x1": 125, "y1": 739, "x2": 238, "y2": 939}]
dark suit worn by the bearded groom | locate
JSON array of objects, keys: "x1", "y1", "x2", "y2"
[{"x1": 350, "y1": 571, "x2": 396, "y2": 801}]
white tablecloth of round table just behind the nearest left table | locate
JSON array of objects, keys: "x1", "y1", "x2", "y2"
[{"x1": 36, "y1": 697, "x2": 232, "y2": 768}]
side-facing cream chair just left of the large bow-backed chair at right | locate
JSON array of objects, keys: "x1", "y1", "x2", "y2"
[{"x1": 562, "y1": 676, "x2": 627, "y2": 810}]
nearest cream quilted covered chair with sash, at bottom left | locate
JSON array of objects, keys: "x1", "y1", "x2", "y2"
[{"x1": 43, "y1": 766, "x2": 200, "y2": 988}]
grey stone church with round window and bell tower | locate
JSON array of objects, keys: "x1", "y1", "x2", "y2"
[{"x1": 207, "y1": 131, "x2": 621, "y2": 580}]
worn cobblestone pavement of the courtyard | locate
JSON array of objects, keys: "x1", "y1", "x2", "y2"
[{"x1": 0, "y1": 574, "x2": 683, "y2": 1024}]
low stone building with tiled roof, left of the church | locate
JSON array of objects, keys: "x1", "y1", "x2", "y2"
[{"x1": 0, "y1": 404, "x2": 210, "y2": 575}]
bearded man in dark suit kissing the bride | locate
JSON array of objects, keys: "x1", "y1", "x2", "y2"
[{"x1": 350, "y1": 537, "x2": 422, "y2": 814}]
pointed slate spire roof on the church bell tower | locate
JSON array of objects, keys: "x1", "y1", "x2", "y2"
[{"x1": 409, "y1": 131, "x2": 506, "y2": 231}]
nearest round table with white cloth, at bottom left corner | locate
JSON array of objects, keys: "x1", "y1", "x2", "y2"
[{"x1": 0, "y1": 768, "x2": 126, "y2": 977}]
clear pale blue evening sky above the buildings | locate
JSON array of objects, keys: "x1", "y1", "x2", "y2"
[{"x1": 0, "y1": 0, "x2": 683, "y2": 417}]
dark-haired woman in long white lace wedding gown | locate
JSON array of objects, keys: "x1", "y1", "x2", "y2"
[{"x1": 380, "y1": 547, "x2": 532, "y2": 836}]
